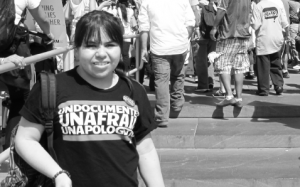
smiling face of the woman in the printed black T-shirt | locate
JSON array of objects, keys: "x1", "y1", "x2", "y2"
[{"x1": 76, "y1": 30, "x2": 121, "y2": 80}]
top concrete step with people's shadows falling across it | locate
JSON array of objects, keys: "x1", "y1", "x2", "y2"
[{"x1": 148, "y1": 94, "x2": 300, "y2": 118}]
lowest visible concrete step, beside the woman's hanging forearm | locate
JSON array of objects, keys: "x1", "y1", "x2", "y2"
[{"x1": 158, "y1": 149, "x2": 300, "y2": 187}]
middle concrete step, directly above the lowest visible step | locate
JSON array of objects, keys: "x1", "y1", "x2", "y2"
[{"x1": 152, "y1": 118, "x2": 300, "y2": 148}]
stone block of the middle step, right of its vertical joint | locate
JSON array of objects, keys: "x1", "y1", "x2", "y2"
[{"x1": 194, "y1": 118, "x2": 300, "y2": 149}]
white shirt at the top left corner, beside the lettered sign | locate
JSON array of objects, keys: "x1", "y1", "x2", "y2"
[{"x1": 14, "y1": 0, "x2": 41, "y2": 25}]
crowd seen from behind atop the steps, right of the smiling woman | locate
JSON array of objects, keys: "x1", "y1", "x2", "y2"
[{"x1": 138, "y1": 0, "x2": 300, "y2": 127}]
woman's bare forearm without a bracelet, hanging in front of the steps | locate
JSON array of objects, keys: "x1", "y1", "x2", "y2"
[{"x1": 137, "y1": 133, "x2": 165, "y2": 187}]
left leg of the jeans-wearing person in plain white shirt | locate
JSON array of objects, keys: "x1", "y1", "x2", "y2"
[{"x1": 150, "y1": 53, "x2": 171, "y2": 127}]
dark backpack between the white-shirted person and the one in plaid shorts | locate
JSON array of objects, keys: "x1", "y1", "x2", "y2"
[{"x1": 199, "y1": 4, "x2": 217, "y2": 39}]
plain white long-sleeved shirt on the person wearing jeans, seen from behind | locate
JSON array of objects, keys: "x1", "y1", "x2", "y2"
[{"x1": 138, "y1": 0, "x2": 195, "y2": 55}]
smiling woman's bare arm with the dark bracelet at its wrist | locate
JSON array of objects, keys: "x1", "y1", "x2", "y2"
[{"x1": 15, "y1": 118, "x2": 72, "y2": 187}]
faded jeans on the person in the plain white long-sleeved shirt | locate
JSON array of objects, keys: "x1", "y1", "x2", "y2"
[{"x1": 150, "y1": 52, "x2": 187, "y2": 125}]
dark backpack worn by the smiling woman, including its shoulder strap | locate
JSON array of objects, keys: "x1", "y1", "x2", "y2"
[{"x1": 0, "y1": 72, "x2": 57, "y2": 187}]
